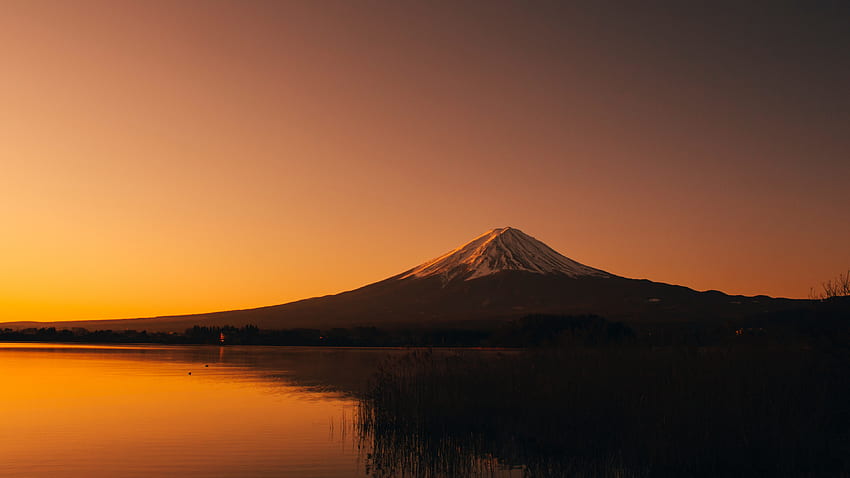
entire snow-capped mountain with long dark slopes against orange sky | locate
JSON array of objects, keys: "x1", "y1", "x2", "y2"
[{"x1": 0, "y1": 227, "x2": 807, "y2": 331}]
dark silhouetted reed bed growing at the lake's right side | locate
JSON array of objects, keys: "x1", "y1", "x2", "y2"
[{"x1": 358, "y1": 344, "x2": 850, "y2": 476}]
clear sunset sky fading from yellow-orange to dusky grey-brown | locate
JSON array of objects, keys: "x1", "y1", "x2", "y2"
[{"x1": 0, "y1": 0, "x2": 850, "y2": 321}]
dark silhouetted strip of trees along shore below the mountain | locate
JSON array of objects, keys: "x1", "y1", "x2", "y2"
[{"x1": 0, "y1": 297, "x2": 850, "y2": 348}]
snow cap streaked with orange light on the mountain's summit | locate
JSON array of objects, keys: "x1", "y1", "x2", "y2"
[{"x1": 399, "y1": 227, "x2": 611, "y2": 281}]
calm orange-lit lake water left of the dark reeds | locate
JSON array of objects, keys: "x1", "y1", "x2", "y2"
[{"x1": 0, "y1": 344, "x2": 414, "y2": 477}]
